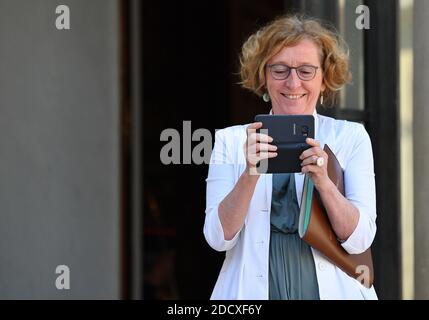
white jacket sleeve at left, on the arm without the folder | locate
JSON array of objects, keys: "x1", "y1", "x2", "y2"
[{"x1": 204, "y1": 129, "x2": 241, "y2": 251}]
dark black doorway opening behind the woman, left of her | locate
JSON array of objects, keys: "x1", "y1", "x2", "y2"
[{"x1": 142, "y1": 1, "x2": 283, "y2": 299}]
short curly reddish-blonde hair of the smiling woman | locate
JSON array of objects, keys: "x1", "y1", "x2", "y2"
[{"x1": 240, "y1": 15, "x2": 351, "y2": 105}]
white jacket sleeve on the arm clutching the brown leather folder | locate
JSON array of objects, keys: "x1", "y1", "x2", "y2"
[{"x1": 342, "y1": 124, "x2": 377, "y2": 254}]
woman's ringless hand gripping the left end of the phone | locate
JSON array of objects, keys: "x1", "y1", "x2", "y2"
[{"x1": 244, "y1": 122, "x2": 277, "y2": 175}]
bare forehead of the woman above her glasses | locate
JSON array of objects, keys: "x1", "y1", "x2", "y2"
[{"x1": 270, "y1": 39, "x2": 320, "y2": 66}]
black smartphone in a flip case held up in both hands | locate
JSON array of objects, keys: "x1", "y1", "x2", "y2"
[{"x1": 255, "y1": 114, "x2": 314, "y2": 173}]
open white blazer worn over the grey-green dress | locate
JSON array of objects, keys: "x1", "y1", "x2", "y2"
[{"x1": 204, "y1": 112, "x2": 377, "y2": 300}]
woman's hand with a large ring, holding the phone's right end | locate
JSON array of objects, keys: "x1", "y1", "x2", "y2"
[{"x1": 299, "y1": 138, "x2": 332, "y2": 192}]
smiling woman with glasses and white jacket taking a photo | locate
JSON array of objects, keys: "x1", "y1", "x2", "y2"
[{"x1": 204, "y1": 16, "x2": 377, "y2": 299}]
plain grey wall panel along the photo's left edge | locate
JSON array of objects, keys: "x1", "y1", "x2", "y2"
[{"x1": 0, "y1": 0, "x2": 120, "y2": 299}]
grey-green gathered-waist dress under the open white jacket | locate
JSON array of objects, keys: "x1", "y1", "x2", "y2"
[{"x1": 269, "y1": 173, "x2": 319, "y2": 300}]
